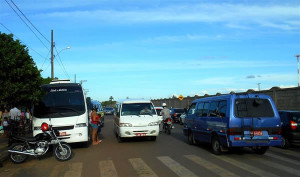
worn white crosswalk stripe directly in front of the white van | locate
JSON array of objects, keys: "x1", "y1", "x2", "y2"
[{"x1": 129, "y1": 158, "x2": 158, "y2": 177}]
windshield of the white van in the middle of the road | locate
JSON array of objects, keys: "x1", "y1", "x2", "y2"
[{"x1": 121, "y1": 103, "x2": 156, "y2": 116}]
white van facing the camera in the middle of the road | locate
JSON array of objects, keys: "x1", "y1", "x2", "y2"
[{"x1": 114, "y1": 100, "x2": 159, "y2": 142}]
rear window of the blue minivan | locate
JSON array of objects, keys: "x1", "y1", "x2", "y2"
[{"x1": 234, "y1": 98, "x2": 274, "y2": 118}]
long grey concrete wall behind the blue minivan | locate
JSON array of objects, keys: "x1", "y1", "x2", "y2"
[{"x1": 152, "y1": 87, "x2": 300, "y2": 111}]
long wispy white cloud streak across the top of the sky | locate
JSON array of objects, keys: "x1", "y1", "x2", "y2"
[{"x1": 29, "y1": 3, "x2": 300, "y2": 30}]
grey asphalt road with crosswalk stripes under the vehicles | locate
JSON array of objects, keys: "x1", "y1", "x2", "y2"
[{"x1": 0, "y1": 116, "x2": 300, "y2": 177}]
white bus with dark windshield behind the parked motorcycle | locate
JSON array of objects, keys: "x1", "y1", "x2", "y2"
[{"x1": 32, "y1": 80, "x2": 91, "y2": 146}]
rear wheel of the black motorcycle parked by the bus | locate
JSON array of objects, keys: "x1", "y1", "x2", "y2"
[{"x1": 9, "y1": 143, "x2": 28, "y2": 164}]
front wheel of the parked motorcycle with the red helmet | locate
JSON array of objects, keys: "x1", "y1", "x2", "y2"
[{"x1": 54, "y1": 143, "x2": 72, "y2": 161}]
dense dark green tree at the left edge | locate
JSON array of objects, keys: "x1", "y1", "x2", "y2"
[{"x1": 0, "y1": 32, "x2": 42, "y2": 107}]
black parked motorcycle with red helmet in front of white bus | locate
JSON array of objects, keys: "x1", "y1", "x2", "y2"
[{"x1": 8, "y1": 122, "x2": 72, "y2": 164}]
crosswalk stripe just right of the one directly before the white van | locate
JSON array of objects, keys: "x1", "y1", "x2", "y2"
[{"x1": 157, "y1": 156, "x2": 197, "y2": 177}]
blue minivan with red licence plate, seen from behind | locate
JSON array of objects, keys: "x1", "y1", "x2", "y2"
[{"x1": 183, "y1": 94, "x2": 282, "y2": 155}]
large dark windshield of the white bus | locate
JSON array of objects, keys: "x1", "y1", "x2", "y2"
[{"x1": 33, "y1": 84, "x2": 85, "y2": 118}]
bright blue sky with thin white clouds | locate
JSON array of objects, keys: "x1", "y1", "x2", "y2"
[{"x1": 0, "y1": 0, "x2": 300, "y2": 101}]
